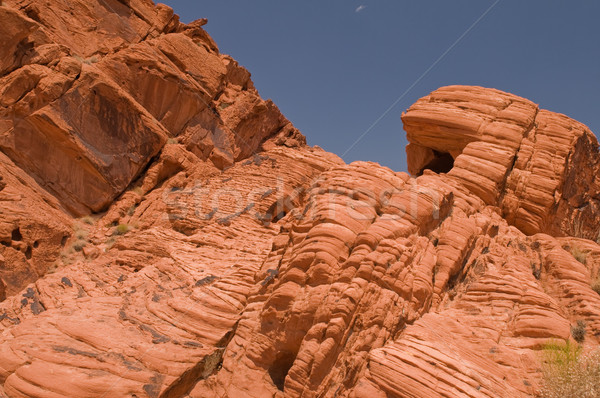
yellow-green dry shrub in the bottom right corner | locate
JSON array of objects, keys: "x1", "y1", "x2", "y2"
[{"x1": 538, "y1": 342, "x2": 600, "y2": 398}]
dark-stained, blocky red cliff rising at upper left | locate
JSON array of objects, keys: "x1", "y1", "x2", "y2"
[{"x1": 0, "y1": 0, "x2": 302, "y2": 215}]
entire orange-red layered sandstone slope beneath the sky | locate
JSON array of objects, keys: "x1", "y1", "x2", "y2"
[{"x1": 0, "y1": 0, "x2": 600, "y2": 398}]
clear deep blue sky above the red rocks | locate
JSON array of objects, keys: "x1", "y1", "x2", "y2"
[{"x1": 165, "y1": 0, "x2": 600, "y2": 171}]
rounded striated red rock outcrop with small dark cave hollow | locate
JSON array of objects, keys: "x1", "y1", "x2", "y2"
[{"x1": 402, "y1": 86, "x2": 600, "y2": 240}]
